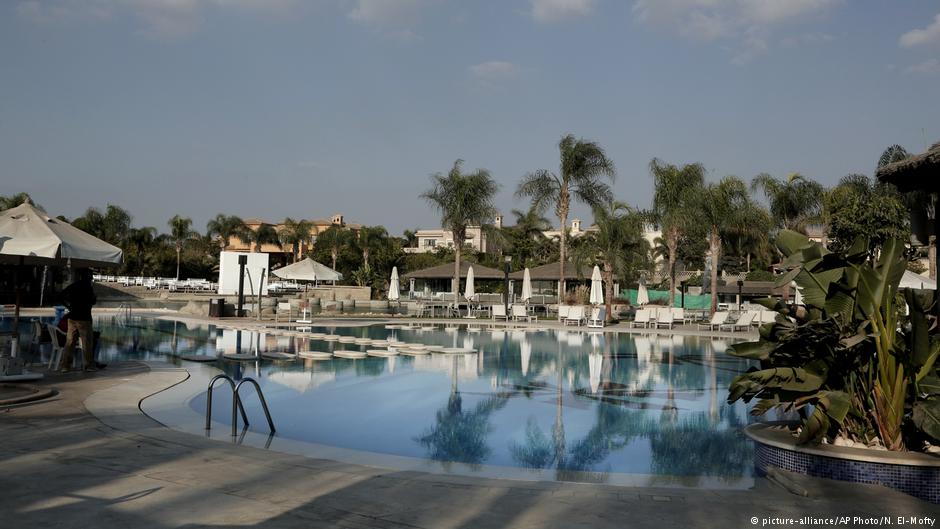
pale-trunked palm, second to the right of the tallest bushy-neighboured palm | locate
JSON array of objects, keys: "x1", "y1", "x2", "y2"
[{"x1": 698, "y1": 176, "x2": 753, "y2": 314}]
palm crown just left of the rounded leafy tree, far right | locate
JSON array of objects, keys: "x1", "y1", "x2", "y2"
[{"x1": 751, "y1": 173, "x2": 826, "y2": 233}]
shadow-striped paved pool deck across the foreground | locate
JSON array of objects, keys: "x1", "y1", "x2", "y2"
[{"x1": 0, "y1": 363, "x2": 940, "y2": 529}]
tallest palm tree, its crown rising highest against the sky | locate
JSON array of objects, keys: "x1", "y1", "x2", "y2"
[{"x1": 516, "y1": 134, "x2": 616, "y2": 294}]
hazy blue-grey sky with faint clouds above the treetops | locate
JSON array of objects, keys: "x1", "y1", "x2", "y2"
[{"x1": 0, "y1": 0, "x2": 940, "y2": 234}]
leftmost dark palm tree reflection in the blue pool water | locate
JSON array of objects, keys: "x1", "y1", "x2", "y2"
[{"x1": 415, "y1": 355, "x2": 509, "y2": 467}]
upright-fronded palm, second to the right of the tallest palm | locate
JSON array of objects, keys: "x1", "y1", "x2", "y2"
[{"x1": 650, "y1": 158, "x2": 705, "y2": 306}]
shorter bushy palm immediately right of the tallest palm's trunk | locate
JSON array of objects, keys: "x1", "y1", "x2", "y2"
[{"x1": 574, "y1": 202, "x2": 650, "y2": 320}]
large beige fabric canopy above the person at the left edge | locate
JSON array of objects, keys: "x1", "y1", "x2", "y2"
[{"x1": 0, "y1": 203, "x2": 124, "y2": 267}]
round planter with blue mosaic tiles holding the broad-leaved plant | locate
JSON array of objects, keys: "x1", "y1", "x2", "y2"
[{"x1": 744, "y1": 423, "x2": 940, "y2": 503}]
